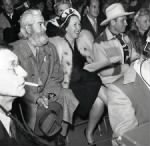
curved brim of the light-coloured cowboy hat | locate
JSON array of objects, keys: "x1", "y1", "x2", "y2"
[{"x1": 100, "y1": 12, "x2": 134, "y2": 26}]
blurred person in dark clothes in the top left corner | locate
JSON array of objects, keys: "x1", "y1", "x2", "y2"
[{"x1": 0, "y1": 0, "x2": 21, "y2": 43}]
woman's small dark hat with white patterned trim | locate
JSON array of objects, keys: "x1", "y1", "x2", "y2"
[{"x1": 59, "y1": 8, "x2": 81, "y2": 27}]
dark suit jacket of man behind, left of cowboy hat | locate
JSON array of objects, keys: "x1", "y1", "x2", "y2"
[{"x1": 81, "y1": 15, "x2": 104, "y2": 39}]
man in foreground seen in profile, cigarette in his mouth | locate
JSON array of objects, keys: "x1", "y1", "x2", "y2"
[{"x1": 0, "y1": 47, "x2": 27, "y2": 146}]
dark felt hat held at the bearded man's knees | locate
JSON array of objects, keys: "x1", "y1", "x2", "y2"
[{"x1": 34, "y1": 102, "x2": 63, "y2": 137}]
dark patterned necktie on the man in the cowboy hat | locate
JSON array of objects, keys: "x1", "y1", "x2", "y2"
[{"x1": 116, "y1": 34, "x2": 130, "y2": 64}]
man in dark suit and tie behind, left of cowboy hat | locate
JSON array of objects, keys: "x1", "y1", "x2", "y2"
[{"x1": 81, "y1": 0, "x2": 104, "y2": 39}]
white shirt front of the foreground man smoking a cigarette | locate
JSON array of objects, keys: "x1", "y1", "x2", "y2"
[{"x1": 0, "y1": 113, "x2": 11, "y2": 136}]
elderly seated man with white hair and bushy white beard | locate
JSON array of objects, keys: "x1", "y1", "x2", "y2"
[{"x1": 12, "y1": 9, "x2": 78, "y2": 145}]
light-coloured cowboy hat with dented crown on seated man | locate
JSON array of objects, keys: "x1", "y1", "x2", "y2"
[{"x1": 100, "y1": 3, "x2": 134, "y2": 26}]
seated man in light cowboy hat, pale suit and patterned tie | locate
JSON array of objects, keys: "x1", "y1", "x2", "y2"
[{"x1": 91, "y1": 3, "x2": 147, "y2": 144}]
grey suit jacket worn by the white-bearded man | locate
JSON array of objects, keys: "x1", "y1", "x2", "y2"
[{"x1": 12, "y1": 40, "x2": 63, "y2": 129}]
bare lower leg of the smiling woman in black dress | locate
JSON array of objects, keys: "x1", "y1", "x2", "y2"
[{"x1": 86, "y1": 97, "x2": 104, "y2": 143}]
